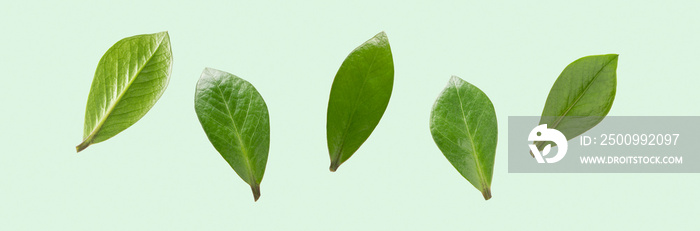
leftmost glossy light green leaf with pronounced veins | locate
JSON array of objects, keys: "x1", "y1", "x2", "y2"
[{"x1": 76, "y1": 32, "x2": 173, "y2": 152}]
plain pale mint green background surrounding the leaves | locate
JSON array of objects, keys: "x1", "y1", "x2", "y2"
[{"x1": 0, "y1": 0, "x2": 700, "y2": 230}]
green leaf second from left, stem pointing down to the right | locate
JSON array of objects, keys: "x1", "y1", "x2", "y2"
[{"x1": 194, "y1": 68, "x2": 270, "y2": 201}]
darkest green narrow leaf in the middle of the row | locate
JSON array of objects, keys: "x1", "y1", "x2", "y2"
[{"x1": 326, "y1": 32, "x2": 394, "y2": 172}]
